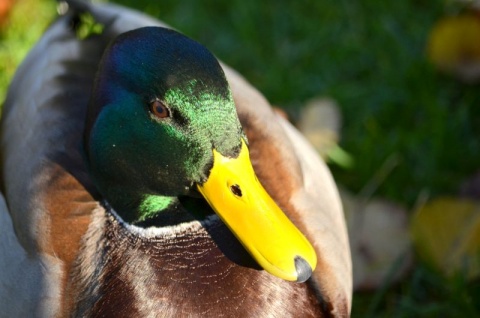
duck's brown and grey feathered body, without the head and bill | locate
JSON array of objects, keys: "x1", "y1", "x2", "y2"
[{"x1": 0, "y1": 2, "x2": 351, "y2": 317}]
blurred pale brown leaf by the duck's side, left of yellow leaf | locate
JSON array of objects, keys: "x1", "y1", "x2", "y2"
[{"x1": 340, "y1": 191, "x2": 412, "y2": 290}]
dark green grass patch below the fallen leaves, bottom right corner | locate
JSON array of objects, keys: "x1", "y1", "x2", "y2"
[{"x1": 352, "y1": 264, "x2": 480, "y2": 318}]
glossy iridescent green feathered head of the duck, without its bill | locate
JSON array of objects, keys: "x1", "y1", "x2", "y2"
[{"x1": 85, "y1": 27, "x2": 243, "y2": 222}]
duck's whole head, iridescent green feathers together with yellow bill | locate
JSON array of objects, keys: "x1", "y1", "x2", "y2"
[{"x1": 85, "y1": 27, "x2": 316, "y2": 282}]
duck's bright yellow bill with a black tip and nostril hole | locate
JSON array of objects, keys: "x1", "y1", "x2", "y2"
[{"x1": 198, "y1": 140, "x2": 317, "y2": 282}]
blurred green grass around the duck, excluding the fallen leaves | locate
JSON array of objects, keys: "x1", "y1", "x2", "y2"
[{"x1": 0, "y1": 0, "x2": 480, "y2": 317}]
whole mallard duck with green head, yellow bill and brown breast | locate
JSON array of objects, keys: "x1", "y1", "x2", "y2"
[{"x1": 0, "y1": 1, "x2": 352, "y2": 317}]
